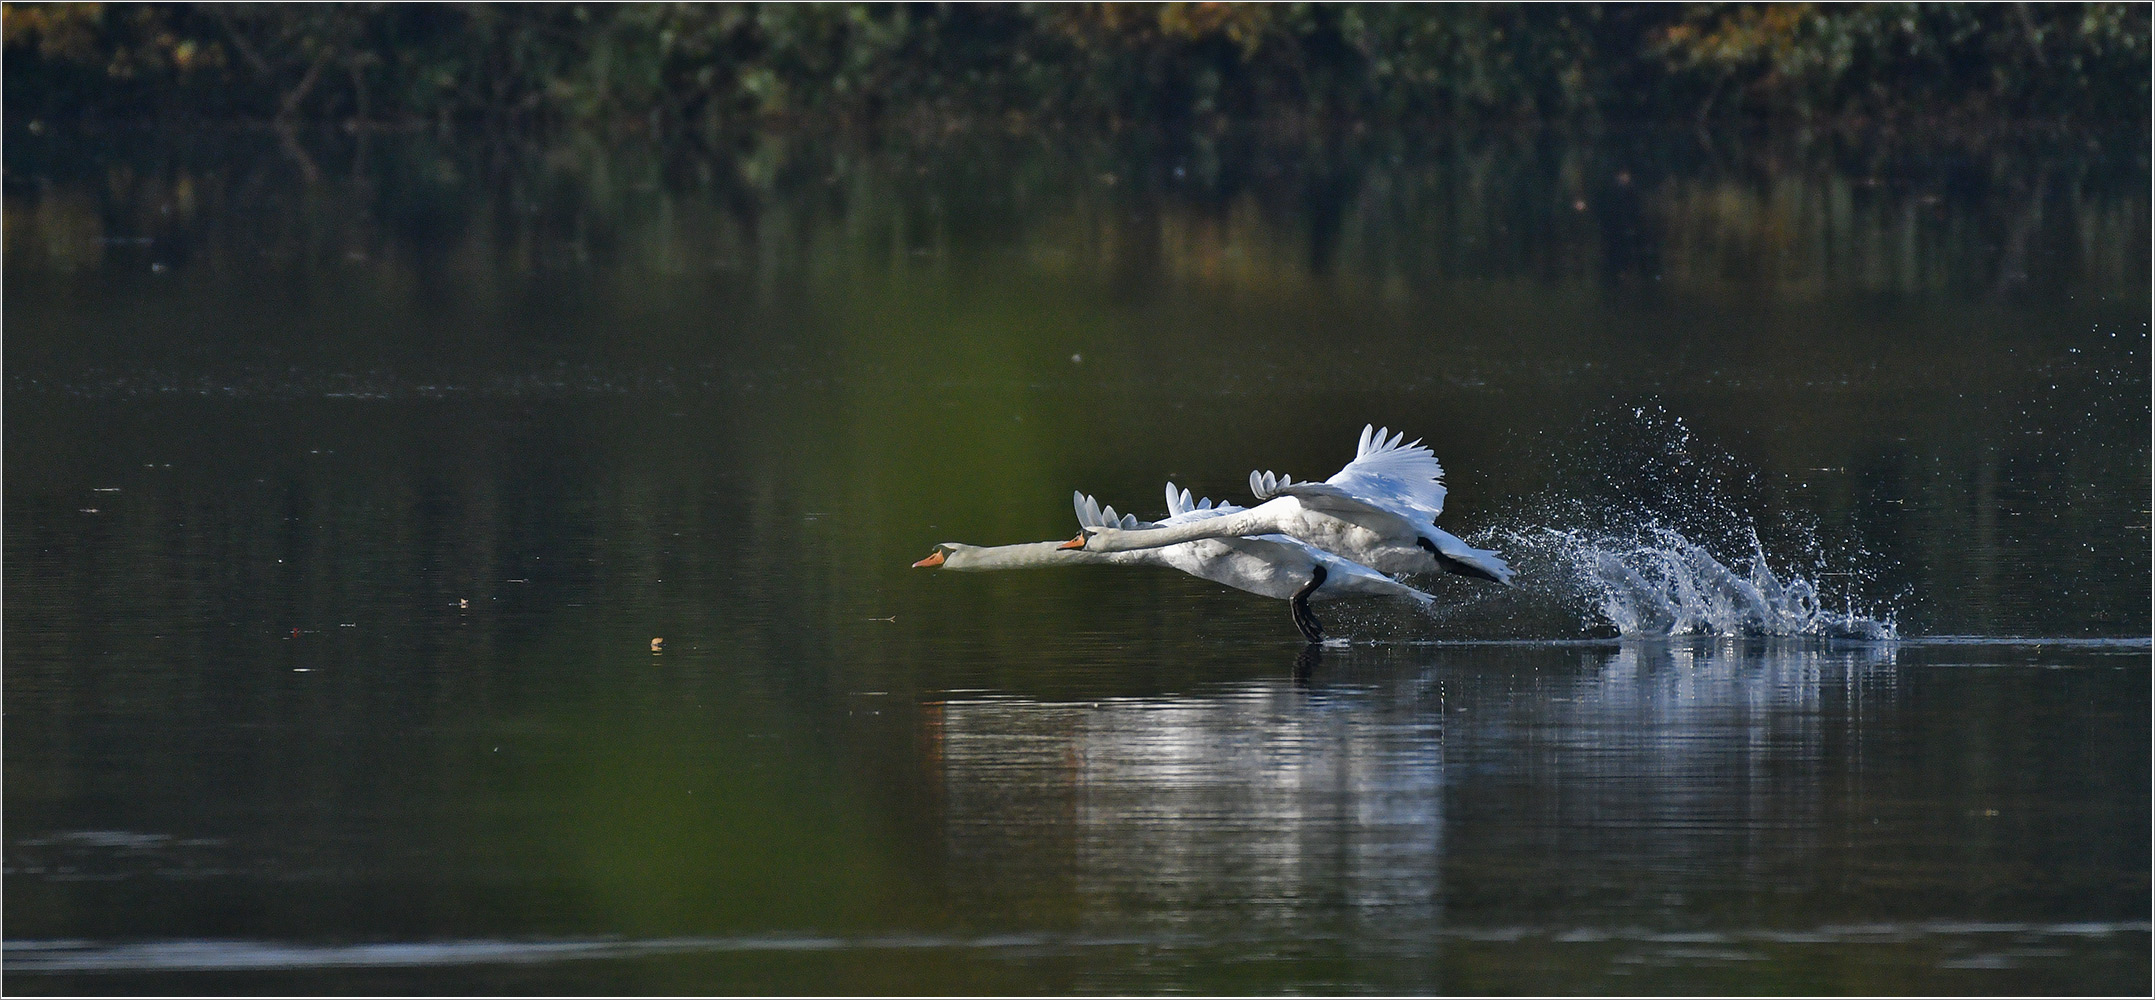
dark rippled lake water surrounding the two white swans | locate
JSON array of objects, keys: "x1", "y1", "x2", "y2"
[{"x1": 0, "y1": 123, "x2": 2151, "y2": 994}]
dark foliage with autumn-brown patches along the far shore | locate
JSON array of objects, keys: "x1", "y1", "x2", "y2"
[{"x1": 4, "y1": 2, "x2": 2149, "y2": 123}]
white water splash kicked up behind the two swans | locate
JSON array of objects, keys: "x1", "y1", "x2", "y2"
[{"x1": 1511, "y1": 524, "x2": 1899, "y2": 640}]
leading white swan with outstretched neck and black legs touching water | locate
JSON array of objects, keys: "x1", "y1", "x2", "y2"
[{"x1": 914, "y1": 483, "x2": 1435, "y2": 642}]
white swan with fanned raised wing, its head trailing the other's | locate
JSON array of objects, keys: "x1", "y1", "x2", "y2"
[{"x1": 1062, "y1": 425, "x2": 1513, "y2": 584}]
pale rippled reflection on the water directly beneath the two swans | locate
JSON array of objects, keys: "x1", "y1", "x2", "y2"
[{"x1": 929, "y1": 679, "x2": 1444, "y2": 942}]
